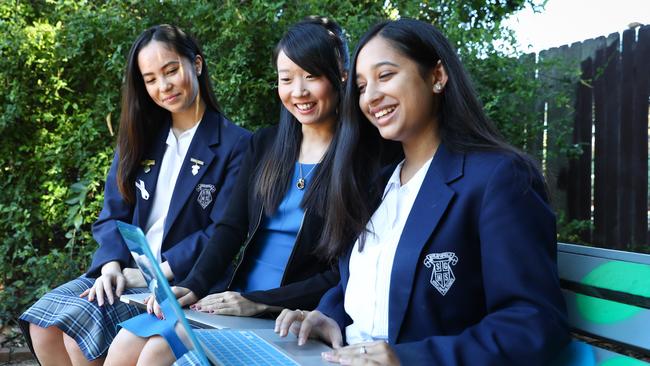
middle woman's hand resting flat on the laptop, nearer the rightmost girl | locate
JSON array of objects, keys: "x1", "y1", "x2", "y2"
[{"x1": 190, "y1": 291, "x2": 269, "y2": 316}]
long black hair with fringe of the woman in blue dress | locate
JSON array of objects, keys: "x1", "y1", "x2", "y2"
[{"x1": 255, "y1": 16, "x2": 350, "y2": 216}]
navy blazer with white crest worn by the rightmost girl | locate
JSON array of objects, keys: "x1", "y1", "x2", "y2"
[{"x1": 318, "y1": 145, "x2": 569, "y2": 366}]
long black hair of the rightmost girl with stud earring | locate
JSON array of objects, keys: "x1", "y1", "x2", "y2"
[{"x1": 319, "y1": 19, "x2": 535, "y2": 258}]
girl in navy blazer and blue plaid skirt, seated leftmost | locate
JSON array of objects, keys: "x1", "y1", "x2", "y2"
[{"x1": 20, "y1": 25, "x2": 250, "y2": 365}]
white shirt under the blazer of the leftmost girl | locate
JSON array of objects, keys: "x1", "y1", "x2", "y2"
[{"x1": 145, "y1": 121, "x2": 201, "y2": 262}]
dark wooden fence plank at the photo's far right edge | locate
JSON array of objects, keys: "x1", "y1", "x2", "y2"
[{"x1": 631, "y1": 26, "x2": 650, "y2": 245}]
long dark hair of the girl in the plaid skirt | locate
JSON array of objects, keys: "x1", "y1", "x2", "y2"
[{"x1": 117, "y1": 24, "x2": 221, "y2": 203}]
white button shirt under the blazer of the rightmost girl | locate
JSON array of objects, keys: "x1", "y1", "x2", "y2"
[{"x1": 344, "y1": 158, "x2": 433, "y2": 344}]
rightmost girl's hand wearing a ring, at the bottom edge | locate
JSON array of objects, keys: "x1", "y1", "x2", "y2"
[{"x1": 323, "y1": 341, "x2": 400, "y2": 365}]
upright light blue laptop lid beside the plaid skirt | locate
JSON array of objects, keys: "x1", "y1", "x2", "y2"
[{"x1": 117, "y1": 221, "x2": 210, "y2": 366}]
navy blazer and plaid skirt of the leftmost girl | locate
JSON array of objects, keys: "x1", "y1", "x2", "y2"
[{"x1": 20, "y1": 109, "x2": 250, "y2": 360}]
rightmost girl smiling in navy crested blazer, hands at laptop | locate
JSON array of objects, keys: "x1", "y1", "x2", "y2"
[{"x1": 276, "y1": 19, "x2": 569, "y2": 365}]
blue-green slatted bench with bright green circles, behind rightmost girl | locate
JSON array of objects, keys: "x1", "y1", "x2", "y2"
[{"x1": 553, "y1": 243, "x2": 650, "y2": 366}]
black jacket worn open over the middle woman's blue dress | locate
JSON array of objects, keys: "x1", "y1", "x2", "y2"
[{"x1": 179, "y1": 126, "x2": 339, "y2": 309}]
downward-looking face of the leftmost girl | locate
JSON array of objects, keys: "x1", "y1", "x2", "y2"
[{"x1": 138, "y1": 40, "x2": 202, "y2": 114}]
